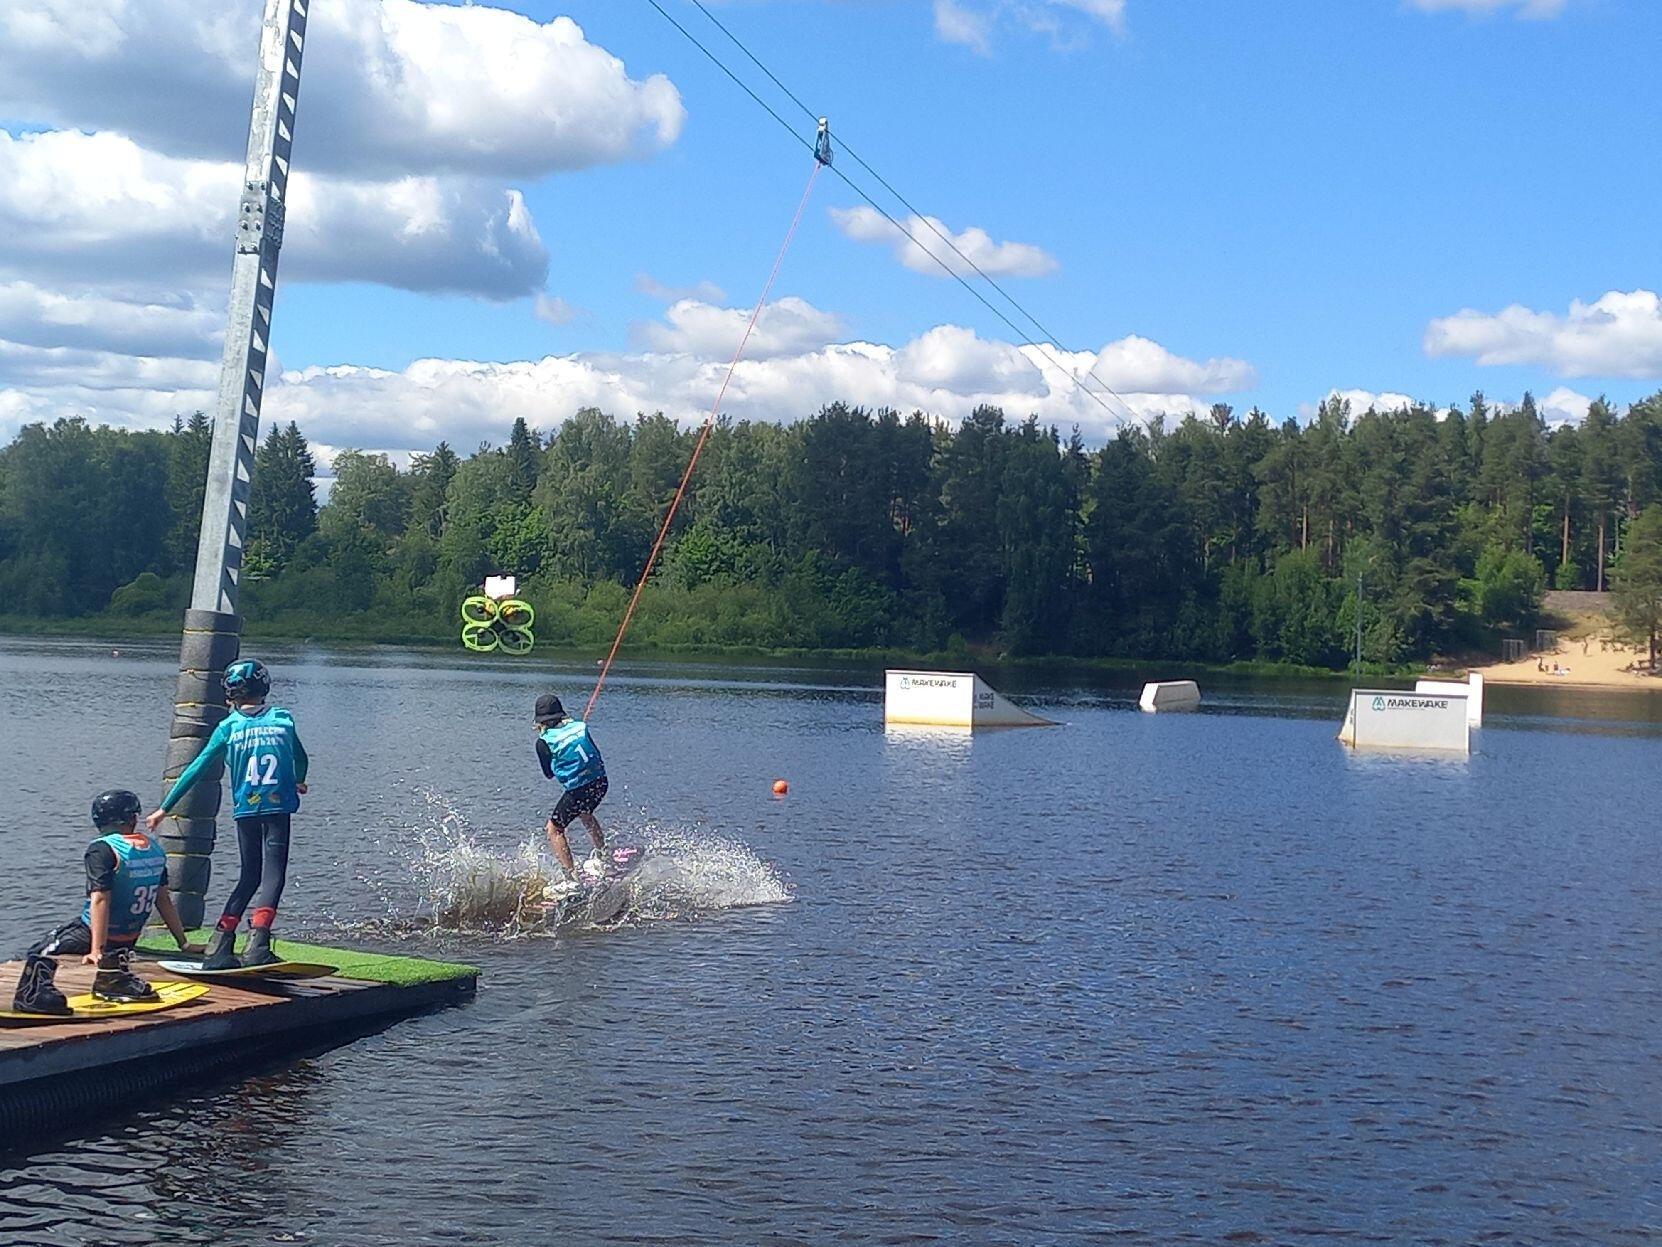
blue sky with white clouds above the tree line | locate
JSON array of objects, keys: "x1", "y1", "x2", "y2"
[{"x1": 0, "y1": 0, "x2": 1662, "y2": 461}]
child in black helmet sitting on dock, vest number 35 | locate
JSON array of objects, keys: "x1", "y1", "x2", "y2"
[{"x1": 12, "y1": 788, "x2": 201, "y2": 1016}]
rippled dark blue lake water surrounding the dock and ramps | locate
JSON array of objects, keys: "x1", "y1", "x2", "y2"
[{"x1": 0, "y1": 638, "x2": 1662, "y2": 1247}]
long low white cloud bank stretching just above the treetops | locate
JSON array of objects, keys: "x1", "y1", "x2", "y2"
[{"x1": 0, "y1": 299, "x2": 1253, "y2": 451}]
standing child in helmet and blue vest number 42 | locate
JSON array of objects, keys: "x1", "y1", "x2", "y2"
[{"x1": 145, "y1": 658, "x2": 307, "y2": 969}]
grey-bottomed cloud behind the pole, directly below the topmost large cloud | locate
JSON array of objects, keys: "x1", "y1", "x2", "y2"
[{"x1": 0, "y1": 131, "x2": 548, "y2": 299}]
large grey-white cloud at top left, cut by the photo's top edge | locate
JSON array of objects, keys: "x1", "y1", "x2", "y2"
[{"x1": 0, "y1": 0, "x2": 686, "y2": 178}]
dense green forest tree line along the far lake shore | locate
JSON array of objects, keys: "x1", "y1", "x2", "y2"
[{"x1": 0, "y1": 394, "x2": 1662, "y2": 668}]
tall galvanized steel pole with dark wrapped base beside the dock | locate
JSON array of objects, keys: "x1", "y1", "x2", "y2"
[{"x1": 161, "y1": 0, "x2": 311, "y2": 926}]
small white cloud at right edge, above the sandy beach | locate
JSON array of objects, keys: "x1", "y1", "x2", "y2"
[{"x1": 1424, "y1": 289, "x2": 1662, "y2": 379}]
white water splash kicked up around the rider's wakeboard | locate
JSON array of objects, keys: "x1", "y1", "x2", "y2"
[{"x1": 403, "y1": 791, "x2": 791, "y2": 936}]
